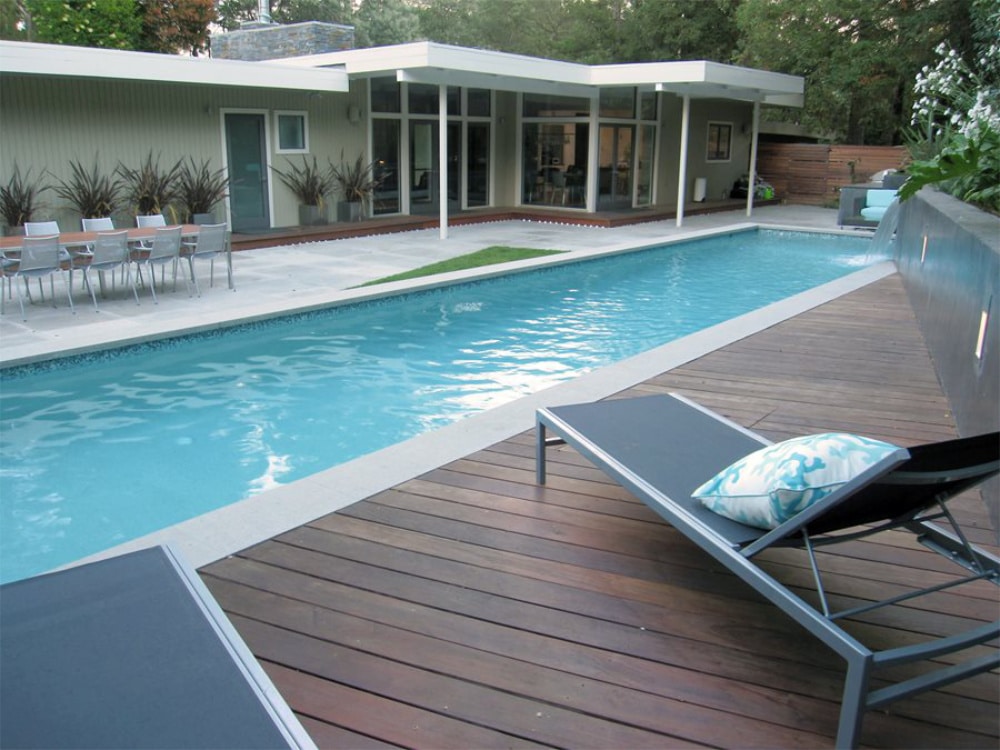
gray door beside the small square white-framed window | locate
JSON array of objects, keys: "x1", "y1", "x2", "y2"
[{"x1": 225, "y1": 112, "x2": 271, "y2": 232}]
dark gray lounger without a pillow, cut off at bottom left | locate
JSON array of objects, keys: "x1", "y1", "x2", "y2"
[{"x1": 0, "y1": 547, "x2": 315, "y2": 750}]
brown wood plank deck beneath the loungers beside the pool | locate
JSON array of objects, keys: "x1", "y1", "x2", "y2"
[{"x1": 201, "y1": 276, "x2": 1000, "y2": 748}]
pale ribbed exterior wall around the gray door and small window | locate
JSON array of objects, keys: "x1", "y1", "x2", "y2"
[{"x1": 0, "y1": 75, "x2": 352, "y2": 231}]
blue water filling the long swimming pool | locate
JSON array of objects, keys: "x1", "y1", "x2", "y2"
[{"x1": 0, "y1": 231, "x2": 870, "y2": 581}]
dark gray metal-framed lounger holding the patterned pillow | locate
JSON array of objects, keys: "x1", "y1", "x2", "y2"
[{"x1": 537, "y1": 395, "x2": 1000, "y2": 748}]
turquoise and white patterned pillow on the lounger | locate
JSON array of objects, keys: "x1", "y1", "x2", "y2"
[{"x1": 692, "y1": 432, "x2": 899, "y2": 529}]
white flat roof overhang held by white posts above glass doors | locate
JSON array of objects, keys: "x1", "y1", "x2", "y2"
[{"x1": 272, "y1": 42, "x2": 805, "y2": 107}]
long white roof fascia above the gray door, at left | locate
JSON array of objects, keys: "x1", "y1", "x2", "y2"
[{"x1": 0, "y1": 42, "x2": 348, "y2": 91}]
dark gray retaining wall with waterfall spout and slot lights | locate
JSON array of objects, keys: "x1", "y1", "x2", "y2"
[{"x1": 895, "y1": 189, "x2": 1000, "y2": 543}]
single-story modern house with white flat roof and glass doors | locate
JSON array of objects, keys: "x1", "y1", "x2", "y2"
[{"x1": 0, "y1": 27, "x2": 803, "y2": 236}]
